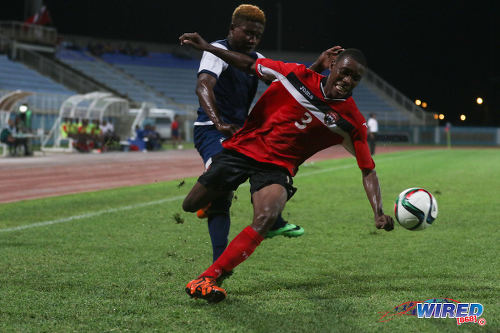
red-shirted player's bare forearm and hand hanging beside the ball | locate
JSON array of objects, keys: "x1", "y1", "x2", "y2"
[{"x1": 362, "y1": 169, "x2": 394, "y2": 231}]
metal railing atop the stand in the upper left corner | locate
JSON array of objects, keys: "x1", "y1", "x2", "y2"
[{"x1": 0, "y1": 21, "x2": 57, "y2": 45}]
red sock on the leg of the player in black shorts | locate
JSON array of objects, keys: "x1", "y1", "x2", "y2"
[{"x1": 199, "y1": 226, "x2": 264, "y2": 278}]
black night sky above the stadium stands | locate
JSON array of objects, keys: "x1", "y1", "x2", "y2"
[{"x1": 0, "y1": 0, "x2": 500, "y2": 126}]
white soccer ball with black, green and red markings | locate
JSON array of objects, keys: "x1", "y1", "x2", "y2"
[{"x1": 394, "y1": 187, "x2": 438, "y2": 231}]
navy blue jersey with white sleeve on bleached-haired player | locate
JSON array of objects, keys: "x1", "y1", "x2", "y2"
[{"x1": 194, "y1": 39, "x2": 263, "y2": 126}]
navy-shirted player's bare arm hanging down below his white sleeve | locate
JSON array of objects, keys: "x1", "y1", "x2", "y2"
[{"x1": 196, "y1": 73, "x2": 239, "y2": 137}]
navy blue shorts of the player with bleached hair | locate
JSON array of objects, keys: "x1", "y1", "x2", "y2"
[{"x1": 194, "y1": 125, "x2": 226, "y2": 167}]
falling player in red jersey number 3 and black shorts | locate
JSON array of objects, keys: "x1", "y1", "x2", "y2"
[{"x1": 179, "y1": 33, "x2": 394, "y2": 302}]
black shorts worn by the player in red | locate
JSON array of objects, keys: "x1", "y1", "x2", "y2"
[{"x1": 198, "y1": 149, "x2": 297, "y2": 200}]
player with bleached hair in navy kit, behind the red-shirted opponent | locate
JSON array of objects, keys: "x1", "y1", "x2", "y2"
[{"x1": 194, "y1": 5, "x2": 341, "y2": 273}]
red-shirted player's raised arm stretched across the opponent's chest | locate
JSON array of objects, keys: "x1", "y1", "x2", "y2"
[{"x1": 179, "y1": 32, "x2": 255, "y2": 74}]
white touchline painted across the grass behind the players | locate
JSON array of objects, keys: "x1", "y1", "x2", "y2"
[{"x1": 0, "y1": 150, "x2": 439, "y2": 233}]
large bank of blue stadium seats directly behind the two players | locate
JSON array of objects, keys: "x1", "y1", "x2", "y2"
[{"x1": 54, "y1": 50, "x2": 409, "y2": 124}]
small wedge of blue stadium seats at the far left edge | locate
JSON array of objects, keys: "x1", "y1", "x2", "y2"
[{"x1": 0, "y1": 55, "x2": 75, "y2": 95}]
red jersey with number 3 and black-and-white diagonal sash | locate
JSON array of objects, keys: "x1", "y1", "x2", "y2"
[{"x1": 222, "y1": 58, "x2": 375, "y2": 176}]
